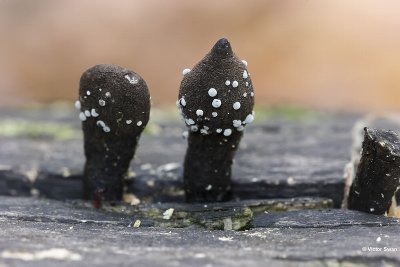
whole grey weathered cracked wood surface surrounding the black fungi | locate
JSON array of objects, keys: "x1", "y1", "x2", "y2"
[{"x1": 0, "y1": 108, "x2": 400, "y2": 267}]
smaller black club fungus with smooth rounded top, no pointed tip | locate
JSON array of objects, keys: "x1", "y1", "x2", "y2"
[{"x1": 78, "y1": 64, "x2": 150, "y2": 203}]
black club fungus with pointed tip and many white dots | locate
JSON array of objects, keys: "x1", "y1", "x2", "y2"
[{"x1": 177, "y1": 38, "x2": 254, "y2": 202}]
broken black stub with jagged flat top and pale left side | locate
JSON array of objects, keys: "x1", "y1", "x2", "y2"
[{"x1": 348, "y1": 128, "x2": 400, "y2": 214}]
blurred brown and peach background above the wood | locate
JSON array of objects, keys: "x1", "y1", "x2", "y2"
[{"x1": 0, "y1": 0, "x2": 400, "y2": 111}]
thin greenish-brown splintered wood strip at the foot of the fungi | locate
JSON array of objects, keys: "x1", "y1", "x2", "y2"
[{"x1": 73, "y1": 198, "x2": 332, "y2": 230}]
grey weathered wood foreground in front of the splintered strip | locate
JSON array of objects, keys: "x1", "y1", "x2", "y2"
[{"x1": 0, "y1": 197, "x2": 400, "y2": 267}]
